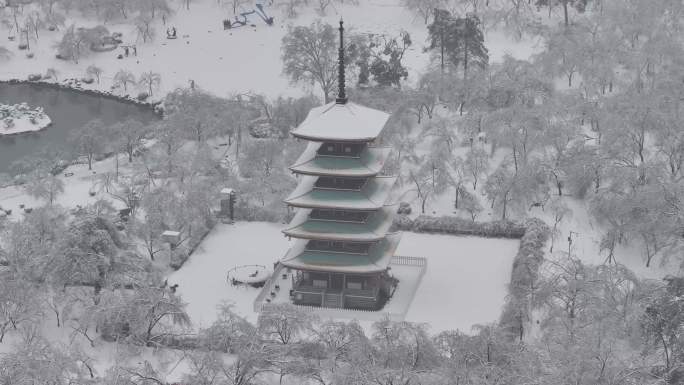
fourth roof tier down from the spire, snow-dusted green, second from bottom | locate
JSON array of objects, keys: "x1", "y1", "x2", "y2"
[{"x1": 283, "y1": 205, "x2": 397, "y2": 242}]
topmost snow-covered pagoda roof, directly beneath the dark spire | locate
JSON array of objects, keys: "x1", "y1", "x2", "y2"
[{"x1": 291, "y1": 102, "x2": 390, "y2": 142}]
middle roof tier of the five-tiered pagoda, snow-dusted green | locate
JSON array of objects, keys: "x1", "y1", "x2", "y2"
[{"x1": 285, "y1": 175, "x2": 397, "y2": 210}]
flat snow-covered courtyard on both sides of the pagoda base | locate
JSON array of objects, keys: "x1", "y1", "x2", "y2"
[{"x1": 168, "y1": 222, "x2": 519, "y2": 332}]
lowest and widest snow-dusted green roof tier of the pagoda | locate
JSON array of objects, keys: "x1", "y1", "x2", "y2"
[{"x1": 280, "y1": 233, "x2": 401, "y2": 274}]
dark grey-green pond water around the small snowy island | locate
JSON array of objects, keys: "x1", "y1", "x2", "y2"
[{"x1": 0, "y1": 83, "x2": 159, "y2": 173}]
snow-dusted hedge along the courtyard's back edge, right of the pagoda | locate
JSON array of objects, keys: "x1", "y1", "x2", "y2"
[{"x1": 393, "y1": 215, "x2": 525, "y2": 239}]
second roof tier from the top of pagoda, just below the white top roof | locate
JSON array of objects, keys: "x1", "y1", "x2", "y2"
[{"x1": 290, "y1": 142, "x2": 392, "y2": 177}]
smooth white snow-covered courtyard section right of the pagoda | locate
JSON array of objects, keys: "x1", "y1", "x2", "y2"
[{"x1": 397, "y1": 232, "x2": 520, "y2": 333}]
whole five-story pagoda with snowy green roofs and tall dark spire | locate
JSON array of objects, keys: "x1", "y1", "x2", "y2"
[{"x1": 280, "y1": 21, "x2": 400, "y2": 310}]
